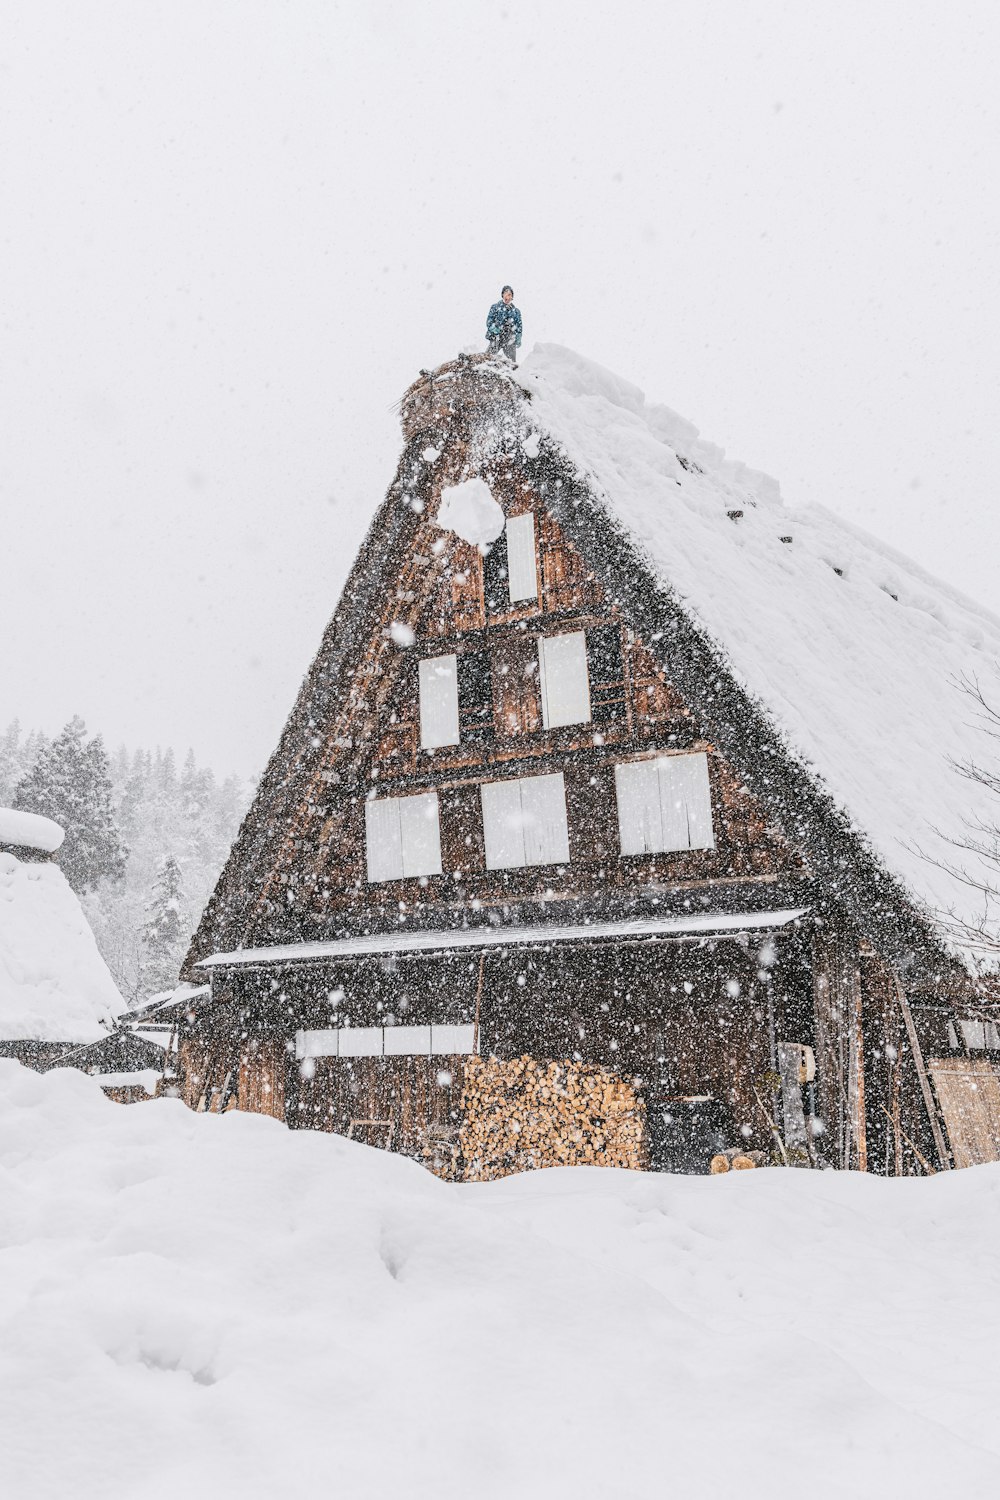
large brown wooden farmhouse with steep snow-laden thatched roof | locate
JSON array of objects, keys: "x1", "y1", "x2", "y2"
[{"x1": 181, "y1": 347, "x2": 1000, "y2": 1175}]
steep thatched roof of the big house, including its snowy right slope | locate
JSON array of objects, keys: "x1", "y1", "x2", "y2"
[{"x1": 186, "y1": 348, "x2": 1000, "y2": 975}]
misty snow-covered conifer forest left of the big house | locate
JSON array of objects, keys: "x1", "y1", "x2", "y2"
[{"x1": 0, "y1": 717, "x2": 249, "y2": 1008}]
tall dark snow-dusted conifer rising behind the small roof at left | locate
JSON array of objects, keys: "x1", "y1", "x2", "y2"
[{"x1": 13, "y1": 717, "x2": 127, "y2": 893}]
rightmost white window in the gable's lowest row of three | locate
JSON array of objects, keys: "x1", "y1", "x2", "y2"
[{"x1": 615, "y1": 755, "x2": 715, "y2": 854}]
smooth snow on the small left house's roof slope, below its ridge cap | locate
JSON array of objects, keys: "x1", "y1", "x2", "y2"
[{"x1": 0, "y1": 858, "x2": 124, "y2": 1043}]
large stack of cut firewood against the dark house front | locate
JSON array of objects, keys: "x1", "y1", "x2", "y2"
[{"x1": 459, "y1": 1058, "x2": 646, "y2": 1182}]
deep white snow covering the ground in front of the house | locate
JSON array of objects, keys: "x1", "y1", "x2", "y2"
[{"x1": 0, "y1": 1064, "x2": 1000, "y2": 1500}]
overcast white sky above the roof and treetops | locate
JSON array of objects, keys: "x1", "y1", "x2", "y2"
[{"x1": 0, "y1": 0, "x2": 1000, "y2": 774}]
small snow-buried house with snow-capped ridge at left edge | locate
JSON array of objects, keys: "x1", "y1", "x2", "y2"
[{"x1": 0, "y1": 807, "x2": 124, "y2": 1068}]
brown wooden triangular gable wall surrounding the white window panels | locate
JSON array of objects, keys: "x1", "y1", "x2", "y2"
[{"x1": 243, "y1": 443, "x2": 804, "y2": 944}]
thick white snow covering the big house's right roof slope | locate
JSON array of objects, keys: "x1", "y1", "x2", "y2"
[{"x1": 516, "y1": 344, "x2": 1000, "y2": 942}]
